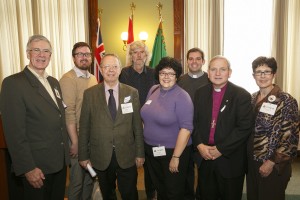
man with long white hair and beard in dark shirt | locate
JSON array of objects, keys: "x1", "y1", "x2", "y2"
[{"x1": 119, "y1": 41, "x2": 157, "y2": 200}]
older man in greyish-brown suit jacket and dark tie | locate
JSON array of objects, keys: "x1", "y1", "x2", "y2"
[{"x1": 79, "y1": 54, "x2": 144, "y2": 200}]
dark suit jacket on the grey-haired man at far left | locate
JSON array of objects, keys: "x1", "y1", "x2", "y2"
[{"x1": 0, "y1": 67, "x2": 69, "y2": 175}]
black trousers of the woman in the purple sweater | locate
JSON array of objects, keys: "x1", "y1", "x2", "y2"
[{"x1": 145, "y1": 143, "x2": 191, "y2": 200}]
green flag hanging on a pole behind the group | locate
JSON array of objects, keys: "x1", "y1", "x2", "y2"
[{"x1": 150, "y1": 20, "x2": 167, "y2": 68}]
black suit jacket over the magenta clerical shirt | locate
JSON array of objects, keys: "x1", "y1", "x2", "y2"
[{"x1": 192, "y1": 82, "x2": 253, "y2": 178}]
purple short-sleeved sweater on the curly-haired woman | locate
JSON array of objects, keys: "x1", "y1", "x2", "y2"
[{"x1": 141, "y1": 84, "x2": 194, "y2": 148}]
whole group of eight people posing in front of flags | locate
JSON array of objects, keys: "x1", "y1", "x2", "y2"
[{"x1": 0, "y1": 35, "x2": 299, "y2": 200}]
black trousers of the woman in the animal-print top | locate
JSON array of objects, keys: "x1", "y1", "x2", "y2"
[{"x1": 247, "y1": 159, "x2": 292, "y2": 200}]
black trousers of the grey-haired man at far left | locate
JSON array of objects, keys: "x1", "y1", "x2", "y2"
[{"x1": 22, "y1": 166, "x2": 67, "y2": 200}]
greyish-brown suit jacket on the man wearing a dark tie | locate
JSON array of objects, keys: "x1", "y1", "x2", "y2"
[{"x1": 79, "y1": 83, "x2": 144, "y2": 170}]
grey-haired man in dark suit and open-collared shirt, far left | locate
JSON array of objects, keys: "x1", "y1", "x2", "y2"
[{"x1": 0, "y1": 35, "x2": 70, "y2": 200}]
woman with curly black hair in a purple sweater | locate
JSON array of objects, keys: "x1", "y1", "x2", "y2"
[{"x1": 141, "y1": 57, "x2": 194, "y2": 200}]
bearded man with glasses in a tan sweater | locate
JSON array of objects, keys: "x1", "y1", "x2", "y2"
[{"x1": 59, "y1": 42, "x2": 97, "y2": 200}]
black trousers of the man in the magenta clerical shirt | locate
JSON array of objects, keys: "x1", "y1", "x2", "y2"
[{"x1": 198, "y1": 160, "x2": 245, "y2": 200}]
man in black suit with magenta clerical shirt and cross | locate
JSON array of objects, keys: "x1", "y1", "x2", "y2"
[{"x1": 193, "y1": 56, "x2": 253, "y2": 200}]
